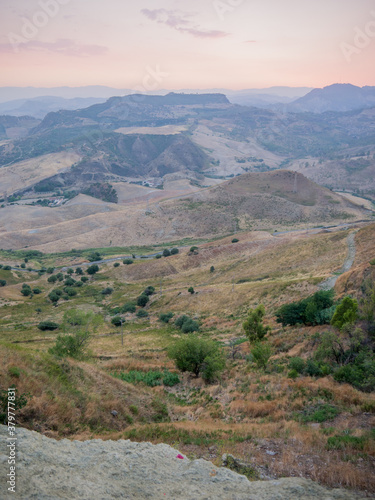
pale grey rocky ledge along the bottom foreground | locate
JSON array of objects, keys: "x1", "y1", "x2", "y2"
[{"x1": 0, "y1": 426, "x2": 360, "y2": 500}]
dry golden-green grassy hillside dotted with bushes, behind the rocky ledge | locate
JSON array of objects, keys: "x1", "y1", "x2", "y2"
[{"x1": 0, "y1": 225, "x2": 375, "y2": 492}]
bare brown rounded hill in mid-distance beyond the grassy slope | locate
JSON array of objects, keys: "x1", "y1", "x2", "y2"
[{"x1": 0, "y1": 171, "x2": 368, "y2": 252}]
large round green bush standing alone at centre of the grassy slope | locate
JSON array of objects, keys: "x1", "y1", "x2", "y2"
[{"x1": 168, "y1": 335, "x2": 225, "y2": 381}]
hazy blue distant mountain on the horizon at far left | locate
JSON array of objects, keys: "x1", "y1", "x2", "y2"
[{"x1": 0, "y1": 96, "x2": 106, "y2": 119}]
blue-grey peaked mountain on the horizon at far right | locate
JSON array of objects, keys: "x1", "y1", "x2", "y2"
[{"x1": 287, "y1": 84, "x2": 375, "y2": 113}]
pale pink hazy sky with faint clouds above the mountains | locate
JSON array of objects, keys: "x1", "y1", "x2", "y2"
[{"x1": 0, "y1": 0, "x2": 375, "y2": 90}]
